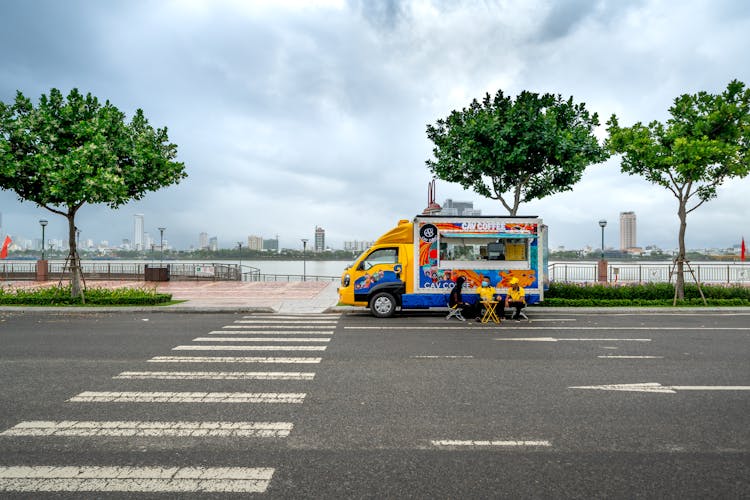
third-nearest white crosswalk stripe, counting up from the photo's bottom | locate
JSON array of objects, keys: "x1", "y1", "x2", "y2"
[{"x1": 68, "y1": 391, "x2": 305, "y2": 404}]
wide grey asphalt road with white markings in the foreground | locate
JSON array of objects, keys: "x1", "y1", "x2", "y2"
[{"x1": 0, "y1": 311, "x2": 750, "y2": 498}]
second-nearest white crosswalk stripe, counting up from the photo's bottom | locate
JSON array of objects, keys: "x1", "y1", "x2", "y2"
[{"x1": 0, "y1": 420, "x2": 294, "y2": 438}]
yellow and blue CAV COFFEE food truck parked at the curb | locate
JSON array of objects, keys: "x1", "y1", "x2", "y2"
[{"x1": 338, "y1": 215, "x2": 549, "y2": 318}]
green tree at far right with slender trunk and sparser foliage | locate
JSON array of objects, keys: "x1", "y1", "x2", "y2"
[{"x1": 606, "y1": 80, "x2": 750, "y2": 300}]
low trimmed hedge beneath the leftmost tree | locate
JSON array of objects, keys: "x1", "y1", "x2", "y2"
[{"x1": 0, "y1": 286, "x2": 172, "y2": 306}]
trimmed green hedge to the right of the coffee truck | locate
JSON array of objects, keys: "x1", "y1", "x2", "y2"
[{"x1": 543, "y1": 283, "x2": 750, "y2": 307}]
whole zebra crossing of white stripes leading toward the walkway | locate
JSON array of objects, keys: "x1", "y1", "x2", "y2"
[{"x1": 0, "y1": 314, "x2": 339, "y2": 493}]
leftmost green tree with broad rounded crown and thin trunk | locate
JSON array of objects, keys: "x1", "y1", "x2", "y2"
[{"x1": 0, "y1": 89, "x2": 187, "y2": 297}]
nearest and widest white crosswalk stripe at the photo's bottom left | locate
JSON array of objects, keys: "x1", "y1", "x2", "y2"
[{"x1": 0, "y1": 466, "x2": 274, "y2": 493}]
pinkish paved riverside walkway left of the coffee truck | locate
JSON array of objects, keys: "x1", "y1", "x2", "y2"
[{"x1": 0, "y1": 280, "x2": 338, "y2": 314}]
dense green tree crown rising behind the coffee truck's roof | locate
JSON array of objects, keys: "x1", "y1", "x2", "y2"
[{"x1": 426, "y1": 90, "x2": 609, "y2": 215}]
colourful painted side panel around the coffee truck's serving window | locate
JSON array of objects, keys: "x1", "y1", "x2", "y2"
[{"x1": 418, "y1": 221, "x2": 539, "y2": 291}]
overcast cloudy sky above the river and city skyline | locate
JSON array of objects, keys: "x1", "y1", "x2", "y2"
[{"x1": 0, "y1": 0, "x2": 750, "y2": 248}]
